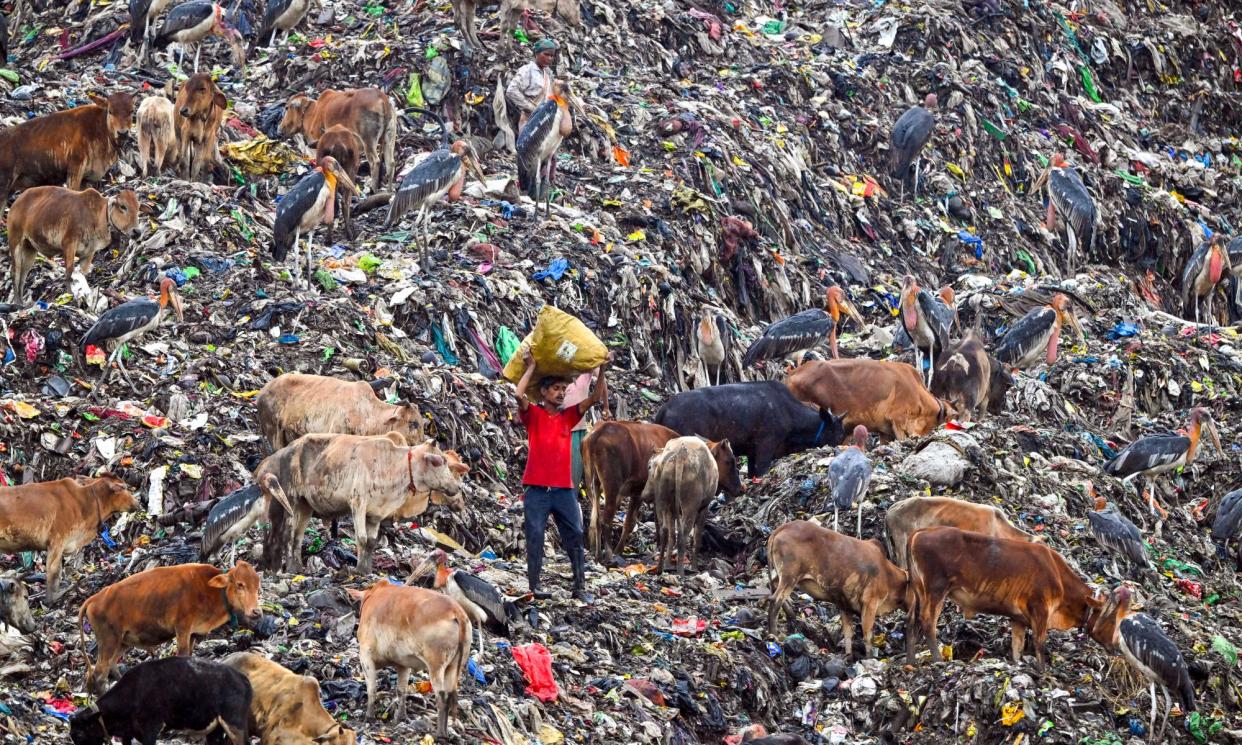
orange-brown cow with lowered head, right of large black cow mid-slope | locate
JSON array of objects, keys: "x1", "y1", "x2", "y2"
[{"x1": 785, "y1": 359, "x2": 953, "y2": 440}]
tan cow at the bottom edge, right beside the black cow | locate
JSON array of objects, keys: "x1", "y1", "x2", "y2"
[{"x1": 221, "y1": 652, "x2": 358, "y2": 745}]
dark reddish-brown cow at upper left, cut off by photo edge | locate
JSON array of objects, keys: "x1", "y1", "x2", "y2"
[{"x1": 0, "y1": 93, "x2": 134, "y2": 209}]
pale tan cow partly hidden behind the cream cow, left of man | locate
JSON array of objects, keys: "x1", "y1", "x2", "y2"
[{"x1": 255, "y1": 373, "x2": 422, "y2": 451}]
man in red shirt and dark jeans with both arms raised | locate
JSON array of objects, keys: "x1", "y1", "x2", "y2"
[{"x1": 517, "y1": 350, "x2": 612, "y2": 602}]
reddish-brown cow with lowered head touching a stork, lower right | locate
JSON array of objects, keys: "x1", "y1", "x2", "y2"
[{"x1": 905, "y1": 526, "x2": 1123, "y2": 669}]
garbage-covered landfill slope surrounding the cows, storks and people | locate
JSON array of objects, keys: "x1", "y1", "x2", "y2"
[{"x1": 0, "y1": 0, "x2": 1242, "y2": 745}]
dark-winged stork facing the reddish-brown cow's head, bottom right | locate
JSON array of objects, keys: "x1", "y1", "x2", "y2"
[{"x1": 1115, "y1": 596, "x2": 1195, "y2": 741}]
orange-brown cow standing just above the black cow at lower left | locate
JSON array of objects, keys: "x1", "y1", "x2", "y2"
[{"x1": 78, "y1": 561, "x2": 263, "y2": 692}]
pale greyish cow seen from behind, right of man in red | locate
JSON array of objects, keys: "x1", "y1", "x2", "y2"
[{"x1": 642, "y1": 436, "x2": 733, "y2": 576}]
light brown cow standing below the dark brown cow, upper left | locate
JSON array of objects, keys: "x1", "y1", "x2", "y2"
[{"x1": 9, "y1": 186, "x2": 138, "y2": 303}]
